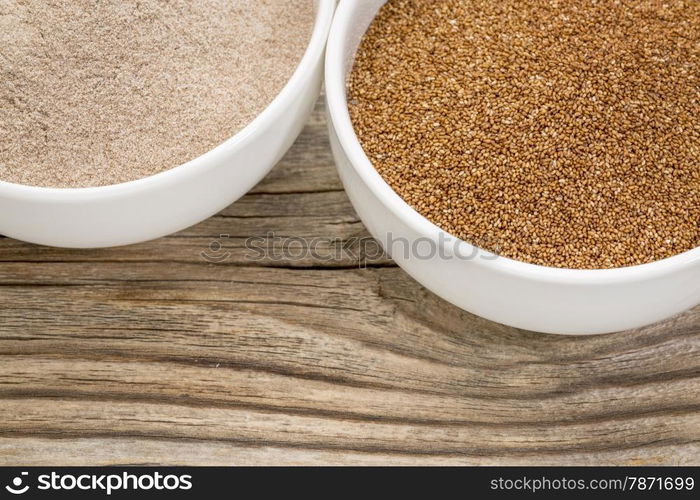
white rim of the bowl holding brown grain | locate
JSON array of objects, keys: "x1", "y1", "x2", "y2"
[{"x1": 325, "y1": 0, "x2": 700, "y2": 285}]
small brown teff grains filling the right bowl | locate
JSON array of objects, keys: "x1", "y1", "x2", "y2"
[{"x1": 349, "y1": 0, "x2": 700, "y2": 269}]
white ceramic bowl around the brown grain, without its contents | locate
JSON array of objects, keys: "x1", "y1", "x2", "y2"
[{"x1": 326, "y1": 0, "x2": 700, "y2": 334}]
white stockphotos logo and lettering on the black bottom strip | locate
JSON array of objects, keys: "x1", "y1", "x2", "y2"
[{"x1": 5, "y1": 471, "x2": 192, "y2": 496}]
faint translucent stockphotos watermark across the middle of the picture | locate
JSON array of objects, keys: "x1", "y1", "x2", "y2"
[{"x1": 200, "y1": 231, "x2": 499, "y2": 268}]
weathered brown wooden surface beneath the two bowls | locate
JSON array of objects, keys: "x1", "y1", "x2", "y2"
[{"x1": 0, "y1": 97, "x2": 700, "y2": 465}]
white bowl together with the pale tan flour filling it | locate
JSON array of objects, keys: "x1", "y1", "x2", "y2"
[{"x1": 0, "y1": 0, "x2": 335, "y2": 248}]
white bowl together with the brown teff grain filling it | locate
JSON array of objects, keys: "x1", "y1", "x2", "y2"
[{"x1": 326, "y1": 0, "x2": 700, "y2": 334}]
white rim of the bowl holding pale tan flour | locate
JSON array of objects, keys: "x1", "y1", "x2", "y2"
[{"x1": 0, "y1": 0, "x2": 336, "y2": 202}]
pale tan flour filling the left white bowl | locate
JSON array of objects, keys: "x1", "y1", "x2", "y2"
[{"x1": 0, "y1": 0, "x2": 314, "y2": 187}]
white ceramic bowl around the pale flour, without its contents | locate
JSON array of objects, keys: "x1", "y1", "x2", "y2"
[{"x1": 0, "y1": 0, "x2": 335, "y2": 248}]
